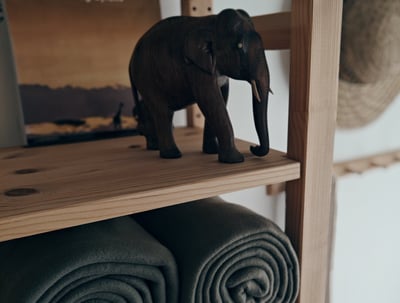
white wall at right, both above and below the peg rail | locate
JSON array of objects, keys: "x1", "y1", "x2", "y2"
[{"x1": 331, "y1": 96, "x2": 400, "y2": 303}]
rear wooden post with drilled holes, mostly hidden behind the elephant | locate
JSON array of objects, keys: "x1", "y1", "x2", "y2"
[{"x1": 181, "y1": 0, "x2": 213, "y2": 127}]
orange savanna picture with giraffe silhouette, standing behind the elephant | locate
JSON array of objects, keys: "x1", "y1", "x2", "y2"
[{"x1": 5, "y1": 0, "x2": 160, "y2": 145}]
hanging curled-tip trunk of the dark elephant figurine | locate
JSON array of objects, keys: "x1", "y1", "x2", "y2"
[{"x1": 249, "y1": 57, "x2": 270, "y2": 157}]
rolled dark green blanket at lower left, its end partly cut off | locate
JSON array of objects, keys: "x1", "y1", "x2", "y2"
[{"x1": 0, "y1": 217, "x2": 178, "y2": 303}]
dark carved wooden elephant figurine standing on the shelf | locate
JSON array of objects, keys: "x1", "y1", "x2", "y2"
[{"x1": 129, "y1": 9, "x2": 270, "y2": 163}]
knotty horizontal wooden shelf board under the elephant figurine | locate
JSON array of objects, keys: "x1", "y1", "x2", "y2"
[{"x1": 0, "y1": 128, "x2": 300, "y2": 241}]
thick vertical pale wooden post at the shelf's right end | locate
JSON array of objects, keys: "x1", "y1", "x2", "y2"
[{"x1": 286, "y1": 0, "x2": 342, "y2": 303}]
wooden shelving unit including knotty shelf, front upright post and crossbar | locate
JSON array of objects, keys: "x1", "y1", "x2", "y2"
[{"x1": 0, "y1": 0, "x2": 342, "y2": 303}]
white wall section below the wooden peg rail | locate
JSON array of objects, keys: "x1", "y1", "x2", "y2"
[{"x1": 331, "y1": 164, "x2": 400, "y2": 303}]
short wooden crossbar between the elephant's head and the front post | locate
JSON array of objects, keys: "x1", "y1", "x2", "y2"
[{"x1": 252, "y1": 12, "x2": 291, "y2": 49}]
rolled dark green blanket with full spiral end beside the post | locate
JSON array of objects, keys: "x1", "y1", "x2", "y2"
[{"x1": 134, "y1": 198, "x2": 299, "y2": 303}]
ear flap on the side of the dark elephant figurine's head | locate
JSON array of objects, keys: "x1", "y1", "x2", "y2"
[{"x1": 184, "y1": 30, "x2": 216, "y2": 75}]
